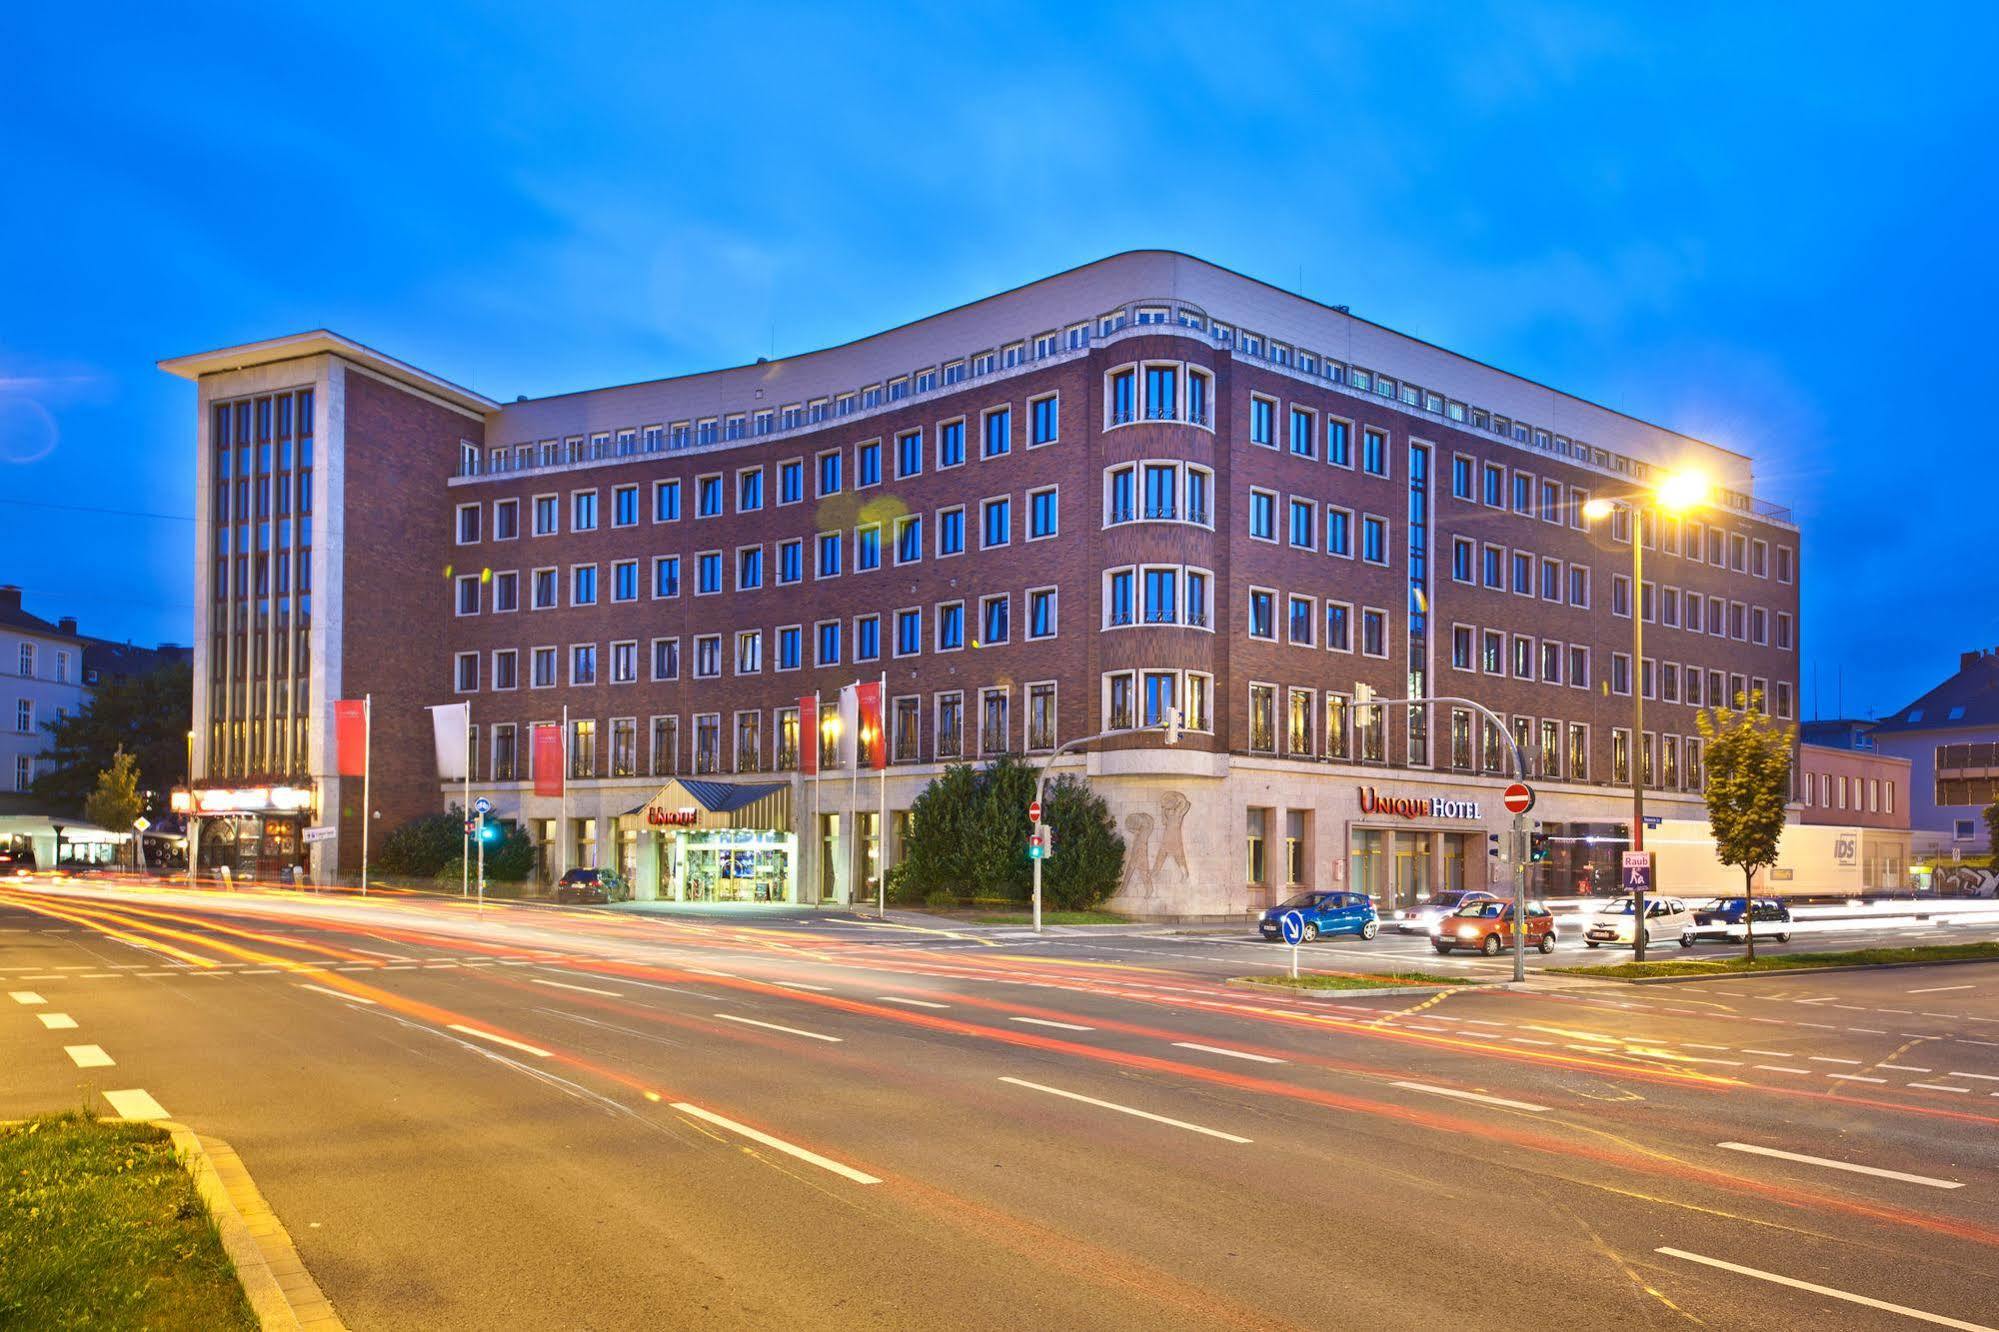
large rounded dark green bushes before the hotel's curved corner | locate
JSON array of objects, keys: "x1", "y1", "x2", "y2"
[{"x1": 890, "y1": 756, "x2": 1123, "y2": 910}]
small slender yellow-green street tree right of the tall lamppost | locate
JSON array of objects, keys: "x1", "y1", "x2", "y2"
[{"x1": 1693, "y1": 694, "x2": 1797, "y2": 962}]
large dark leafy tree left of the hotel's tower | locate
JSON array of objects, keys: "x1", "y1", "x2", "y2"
[{"x1": 34, "y1": 662, "x2": 194, "y2": 818}]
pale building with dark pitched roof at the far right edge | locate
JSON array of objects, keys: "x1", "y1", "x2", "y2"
[{"x1": 1873, "y1": 648, "x2": 1999, "y2": 856}]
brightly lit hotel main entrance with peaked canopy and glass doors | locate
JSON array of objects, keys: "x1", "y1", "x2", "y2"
[{"x1": 618, "y1": 778, "x2": 798, "y2": 902}]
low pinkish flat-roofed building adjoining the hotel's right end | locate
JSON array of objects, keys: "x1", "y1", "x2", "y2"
[{"x1": 1775, "y1": 744, "x2": 1909, "y2": 892}]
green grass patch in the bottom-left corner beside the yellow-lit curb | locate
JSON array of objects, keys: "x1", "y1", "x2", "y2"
[{"x1": 0, "y1": 1114, "x2": 258, "y2": 1332}]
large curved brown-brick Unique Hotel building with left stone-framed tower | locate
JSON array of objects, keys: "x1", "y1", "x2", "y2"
[{"x1": 162, "y1": 252, "x2": 1799, "y2": 914}]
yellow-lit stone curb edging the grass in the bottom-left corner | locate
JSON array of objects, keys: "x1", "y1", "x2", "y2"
[{"x1": 160, "y1": 1120, "x2": 346, "y2": 1332}]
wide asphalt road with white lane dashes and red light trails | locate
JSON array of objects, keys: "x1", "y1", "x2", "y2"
[{"x1": 0, "y1": 886, "x2": 1999, "y2": 1328}]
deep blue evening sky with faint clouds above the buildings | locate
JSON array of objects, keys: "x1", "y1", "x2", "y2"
[{"x1": 0, "y1": 4, "x2": 1999, "y2": 716}]
